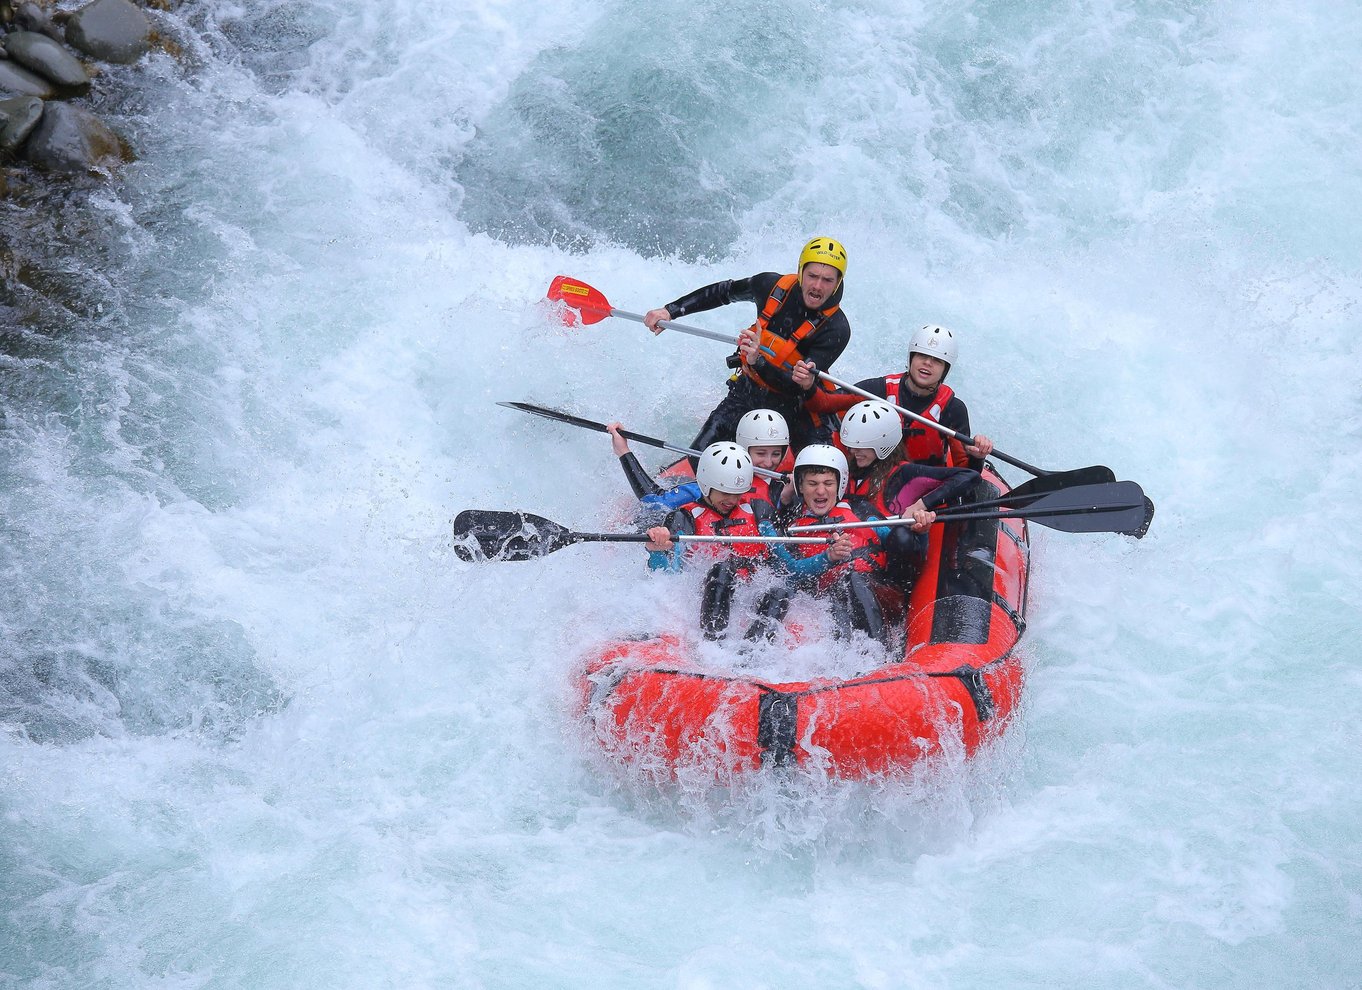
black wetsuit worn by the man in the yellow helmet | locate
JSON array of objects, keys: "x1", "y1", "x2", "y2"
[{"x1": 667, "y1": 271, "x2": 851, "y2": 463}]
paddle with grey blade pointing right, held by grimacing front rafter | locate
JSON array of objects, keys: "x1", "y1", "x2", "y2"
[{"x1": 790, "y1": 481, "x2": 1154, "y2": 539}]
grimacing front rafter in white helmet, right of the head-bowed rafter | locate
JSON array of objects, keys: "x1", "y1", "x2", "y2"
[{"x1": 748, "y1": 444, "x2": 884, "y2": 639}]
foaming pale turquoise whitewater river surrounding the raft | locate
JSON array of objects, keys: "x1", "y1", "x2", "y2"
[{"x1": 0, "y1": 0, "x2": 1362, "y2": 990}]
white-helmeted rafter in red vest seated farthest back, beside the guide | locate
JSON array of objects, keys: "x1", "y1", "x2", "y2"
[{"x1": 795, "y1": 323, "x2": 993, "y2": 470}]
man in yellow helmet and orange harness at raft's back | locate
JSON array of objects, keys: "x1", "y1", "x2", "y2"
[{"x1": 643, "y1": 237, "x2": 851, "y2": 452}]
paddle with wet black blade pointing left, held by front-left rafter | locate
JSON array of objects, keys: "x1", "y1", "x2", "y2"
[{"x1": 454, "y1": 509, "x2": 831, "y2": 562}]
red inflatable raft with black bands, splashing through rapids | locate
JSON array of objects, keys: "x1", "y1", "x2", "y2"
[{"x1": 569, "y1": 470, "x2": 1030, "y2": 778}]
